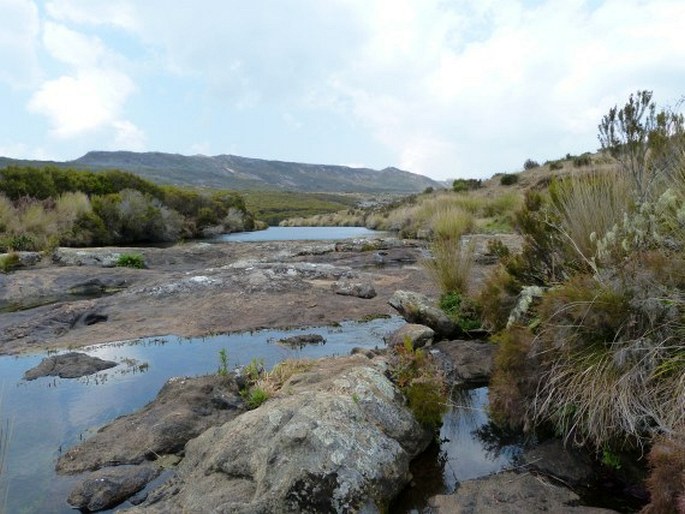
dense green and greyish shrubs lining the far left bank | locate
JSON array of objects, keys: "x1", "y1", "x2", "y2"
[{"x1": 0, "y1": 166, "x2": 254, "y2": 252}]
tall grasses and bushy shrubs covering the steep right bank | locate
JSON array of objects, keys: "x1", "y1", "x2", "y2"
[{"x1": 452, "y1": 91, "x2": 685, "y2": 512}]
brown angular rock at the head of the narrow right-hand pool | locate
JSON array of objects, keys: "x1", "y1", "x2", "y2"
[{"x1": 432, "y1": 341, "x2": 497, "y2": 385}]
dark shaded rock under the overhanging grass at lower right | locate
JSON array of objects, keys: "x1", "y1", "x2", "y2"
[{"x1": 521, "y1": 439, "x2": 596, "y2": 487}]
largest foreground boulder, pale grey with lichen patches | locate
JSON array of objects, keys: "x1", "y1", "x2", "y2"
[{"x1": 123, "y1": 356, "x2": 430, "y2": 514}]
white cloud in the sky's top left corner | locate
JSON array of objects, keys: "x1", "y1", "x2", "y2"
[{"x1": 0, "y1": 0, "x2": 40, "y2": 88}]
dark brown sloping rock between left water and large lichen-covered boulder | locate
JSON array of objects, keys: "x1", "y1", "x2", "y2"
[{"x1": 56, "y1": 375, "x2": 242, "y2": 474}]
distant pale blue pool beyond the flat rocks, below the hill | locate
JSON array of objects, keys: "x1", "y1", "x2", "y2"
[{"x1": 212, "y1": 227, "x2": 387, "y2": 242}]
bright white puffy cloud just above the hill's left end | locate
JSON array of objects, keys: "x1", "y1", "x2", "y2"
[{"x1": 29, "y1": 69, "x2": 135, "y2": 138}]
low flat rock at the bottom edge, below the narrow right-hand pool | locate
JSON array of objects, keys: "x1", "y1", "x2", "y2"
[{"x1": 429, "y1": 471, "x2": 614, "y2": 514}]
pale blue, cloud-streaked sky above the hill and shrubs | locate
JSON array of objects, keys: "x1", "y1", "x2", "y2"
[{"x1": 0, "y1": 0, "x2": 685, "y2": 180}]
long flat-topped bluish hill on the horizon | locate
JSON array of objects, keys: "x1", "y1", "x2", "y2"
[{"x1": 0, "y1": 151, "x2": 442, "y2": 193}]
